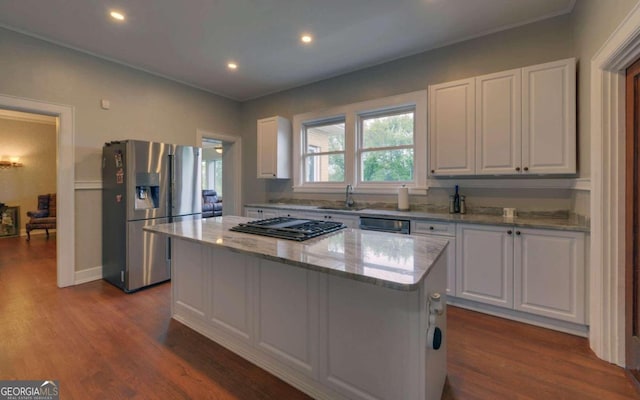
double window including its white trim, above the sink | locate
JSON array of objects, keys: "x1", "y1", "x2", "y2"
[{"x1": 293, "y1": 90, "x2": 427, "y2": 194}]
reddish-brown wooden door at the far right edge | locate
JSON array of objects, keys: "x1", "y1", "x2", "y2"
[{"x1": 625, "y1": 60, "x2": 640, "y2": 388}]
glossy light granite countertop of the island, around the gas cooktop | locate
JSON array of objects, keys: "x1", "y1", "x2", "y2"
[{"x1": 144, "y1": 216, "x2": 447, "y2": 290}]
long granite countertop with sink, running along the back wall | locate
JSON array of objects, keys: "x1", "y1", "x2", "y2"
[{"x1": 245, "y1": 203, "x2": 590, "y2": 233}]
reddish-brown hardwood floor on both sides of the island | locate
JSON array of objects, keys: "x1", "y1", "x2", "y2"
[{"x1": 0, "y1": 234, "x2": 640, "y2": 400}]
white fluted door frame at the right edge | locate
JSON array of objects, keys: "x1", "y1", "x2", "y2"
[{"x1": 589, "y1": 3, "x2": 640, "y2": 367}]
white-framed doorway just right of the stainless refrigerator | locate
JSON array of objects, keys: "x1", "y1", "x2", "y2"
[{"x1": 197, "y1": 130, "x2": 242, "y2": 215}]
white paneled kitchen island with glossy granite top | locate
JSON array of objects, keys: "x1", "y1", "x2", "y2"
[{"x1": 145, "y1": 216, "x2": 447, "y2": 400}]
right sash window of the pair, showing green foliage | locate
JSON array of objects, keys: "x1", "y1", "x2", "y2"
[{"x1": 359, "y1": 109, "x2": 415, "y2": 182}]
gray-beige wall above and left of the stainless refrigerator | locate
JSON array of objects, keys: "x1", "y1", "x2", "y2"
[{"x1": 0, "y1": 29, "x2": 240, "y2": 271}]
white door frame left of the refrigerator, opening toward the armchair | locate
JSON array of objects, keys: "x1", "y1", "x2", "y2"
[{"x1": 0, "y1": 94, "x2": 76, "y2": 288}]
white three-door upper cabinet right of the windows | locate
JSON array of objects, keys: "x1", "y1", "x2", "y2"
[{"x1": 429, "y1": 58, "x2": 576, "y2": 176}]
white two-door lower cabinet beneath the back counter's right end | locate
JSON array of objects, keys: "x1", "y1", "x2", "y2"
[{"x1": 456, "y1": 224, "x2": 586, "y2": 324}]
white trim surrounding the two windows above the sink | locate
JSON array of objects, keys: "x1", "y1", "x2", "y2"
[{"x1": 293, "y1": 90, "x2": 428, "y2": 194}]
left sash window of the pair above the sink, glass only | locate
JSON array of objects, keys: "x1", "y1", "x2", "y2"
[{"x1": 302, "y1": 121, "x2": 345, "y2": 182}]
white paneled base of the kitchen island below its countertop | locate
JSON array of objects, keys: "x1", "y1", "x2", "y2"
[{"x1": 172, "y1": 239, "x2": 448, "y2": 400}]
